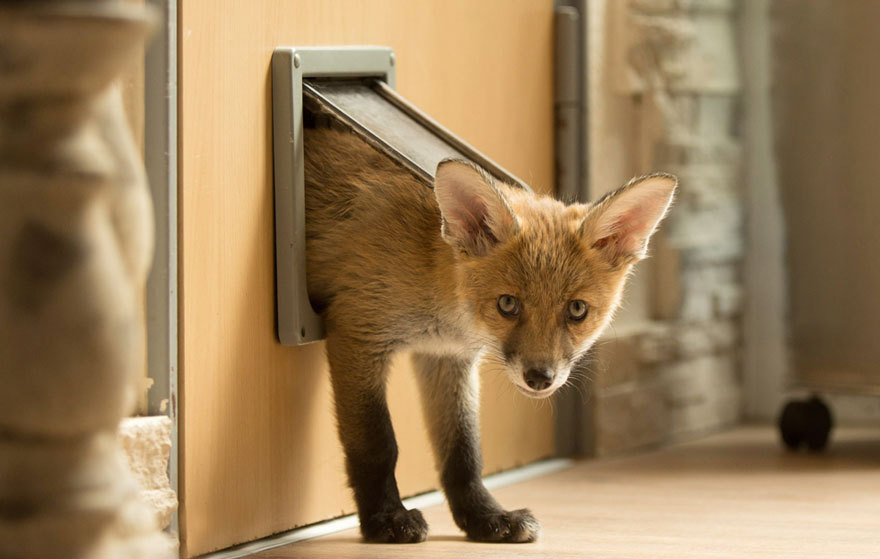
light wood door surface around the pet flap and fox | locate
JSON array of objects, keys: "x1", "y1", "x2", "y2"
[{"x1": 179, "y1": 0, "x2": 554, "y2": 556}]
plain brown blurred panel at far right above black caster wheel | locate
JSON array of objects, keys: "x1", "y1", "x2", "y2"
[{"x1": 770, "y1": 0, "x2": 880, "y2": 421}]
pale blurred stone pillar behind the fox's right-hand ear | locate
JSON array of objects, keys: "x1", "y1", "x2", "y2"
[{"x1": 595, "y1": 0, "x2": 744, "y2": 454}]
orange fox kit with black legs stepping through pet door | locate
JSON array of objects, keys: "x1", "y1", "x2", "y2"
[{"x1": 305, "y1": 129, "x2": 676, "y2": 542}]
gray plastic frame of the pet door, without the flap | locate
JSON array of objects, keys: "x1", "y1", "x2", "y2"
[{"x1": 272, "y1": 46, "x2": 395, "y2": 346}]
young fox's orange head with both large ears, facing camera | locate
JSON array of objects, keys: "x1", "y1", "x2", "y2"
[{"x1": 434, "y1": 160, "x2": 676, "y2": 398}]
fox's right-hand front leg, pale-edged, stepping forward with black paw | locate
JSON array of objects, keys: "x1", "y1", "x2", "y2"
[{"x1": 413, "y1": 354, "x2": 540, "y2": 542}]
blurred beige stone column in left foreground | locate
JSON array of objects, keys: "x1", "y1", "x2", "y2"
[{"x1": 0, "y1": 1, "x2": 175, "y2": 559}]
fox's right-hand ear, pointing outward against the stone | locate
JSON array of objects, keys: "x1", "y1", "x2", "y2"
[{"x1": 581, "y1": 174, "x2": 678, "y2": 262}]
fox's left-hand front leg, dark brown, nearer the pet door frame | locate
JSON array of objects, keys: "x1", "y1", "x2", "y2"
[{"x1": 327, "y1": 334, "x2": 428, "y2": 543}]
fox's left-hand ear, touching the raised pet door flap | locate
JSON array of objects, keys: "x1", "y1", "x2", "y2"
[{"x1": 434, "y1": 159, "x2": 519, "y2": 256}]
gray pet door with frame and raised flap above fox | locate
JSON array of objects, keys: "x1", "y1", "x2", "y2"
[{"x1": 272, "y1": 47, "x2": 528, "y2": 346}]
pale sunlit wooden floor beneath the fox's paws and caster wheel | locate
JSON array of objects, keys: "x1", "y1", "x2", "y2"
[{"x1": 256, "y1": 427, "x2": 880, "y2": 559}]
